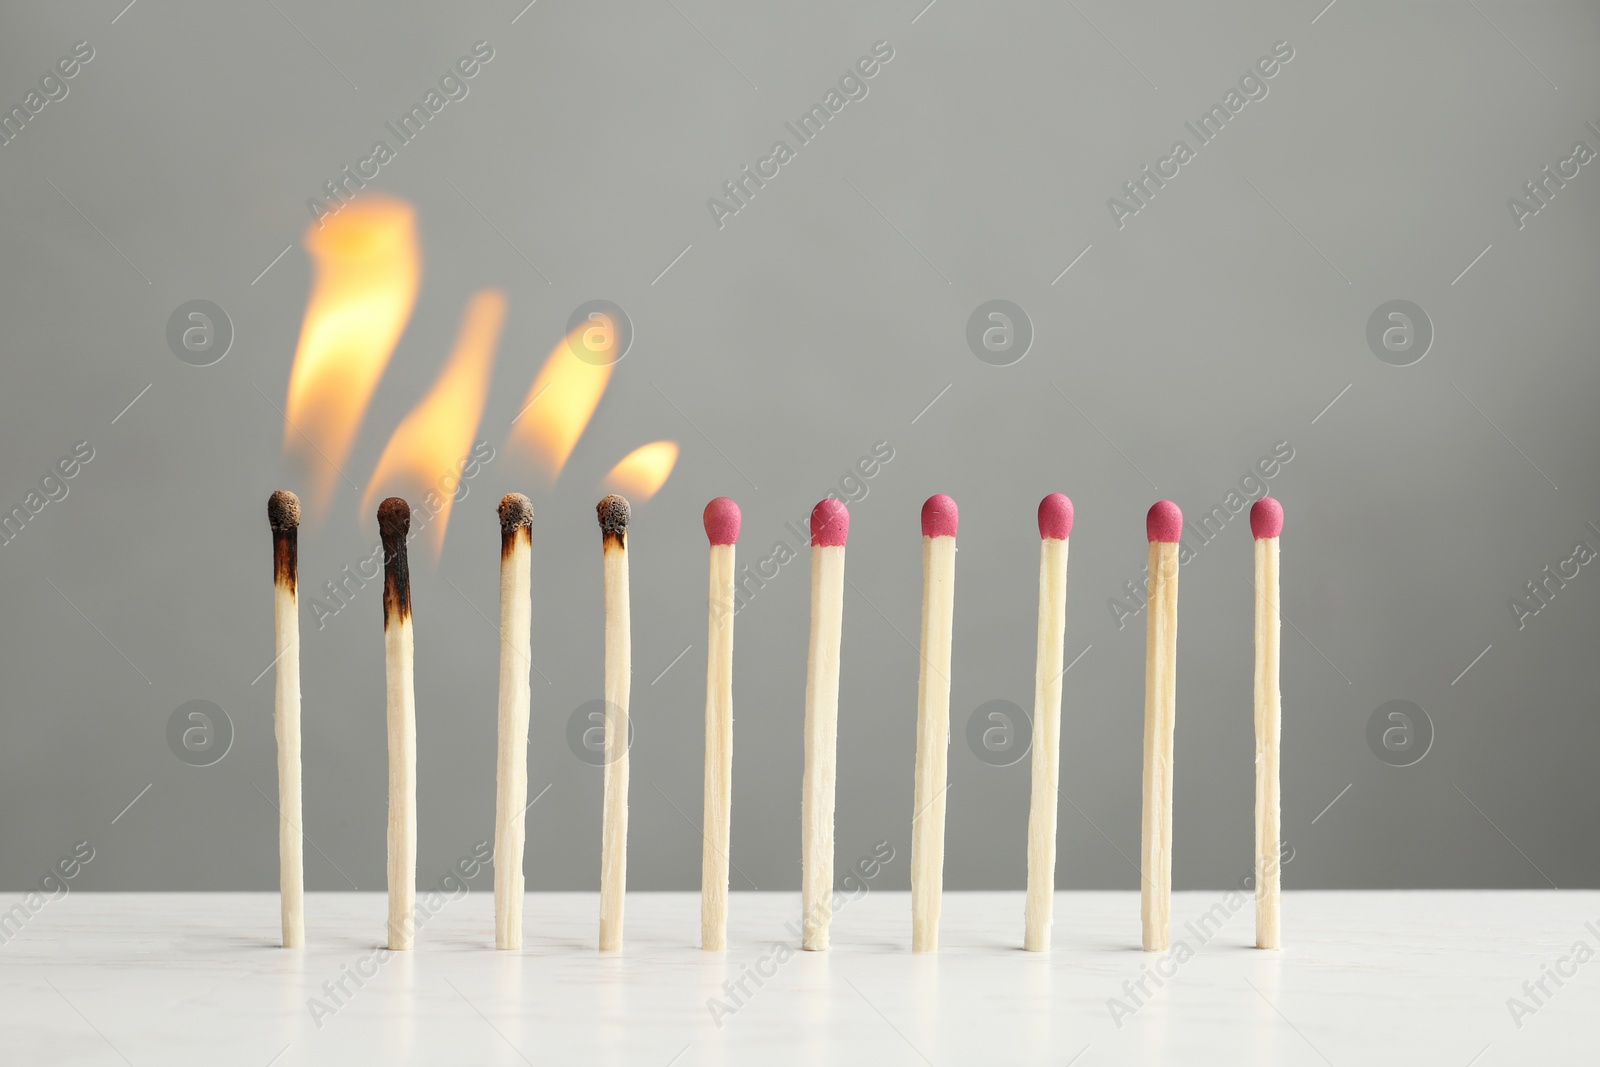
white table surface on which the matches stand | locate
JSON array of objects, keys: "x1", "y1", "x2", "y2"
[{"x1": 0, "y1": 889, "x2": 1600, "y2": 1067}]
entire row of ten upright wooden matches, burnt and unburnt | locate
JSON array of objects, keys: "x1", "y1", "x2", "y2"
[{"x1": 267, "y1": 491, "x2": 1283, "y2": 952}]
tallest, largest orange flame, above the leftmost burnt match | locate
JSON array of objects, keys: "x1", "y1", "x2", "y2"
[{"x1": 283, "y1": 194, "x2": 422, "y2": 510}]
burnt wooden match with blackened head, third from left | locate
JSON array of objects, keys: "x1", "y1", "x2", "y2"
[{"x1": 494, "y1": 493, "x2": 533, "y2": 949}]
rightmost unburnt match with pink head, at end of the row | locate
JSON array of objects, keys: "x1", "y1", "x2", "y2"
[{"x1": 1250, "y1": 496, "x2": 1283, "y2": 949}]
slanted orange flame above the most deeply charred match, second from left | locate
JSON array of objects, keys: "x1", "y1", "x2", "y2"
[{"x1": 362, "y1": 290, "x2": 506, "y2": 561}]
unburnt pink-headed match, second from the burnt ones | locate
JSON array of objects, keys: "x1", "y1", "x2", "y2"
[{"x1": 800, "y1": 498, "x2": 850, "y2": 952}]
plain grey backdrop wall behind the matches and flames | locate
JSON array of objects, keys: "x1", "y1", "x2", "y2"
[{"x1": 0, "y1": 0, "x2": 1600, "y2": 889}]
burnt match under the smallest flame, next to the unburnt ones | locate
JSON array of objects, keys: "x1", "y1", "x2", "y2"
[{"x1": 595, "y1": 494, "x2": 634, "y2": 952}]
